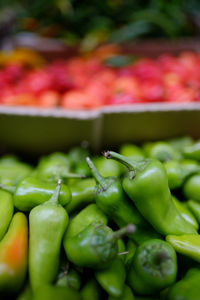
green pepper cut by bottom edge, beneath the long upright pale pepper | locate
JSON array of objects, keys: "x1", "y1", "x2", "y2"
[{"x1": 32, "y1": 285, "x2": 82, "y2": 300}]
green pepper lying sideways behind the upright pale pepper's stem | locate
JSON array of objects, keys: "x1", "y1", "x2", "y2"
[{"x1": 13, "y1": 177, "x2": 71, "y2": 211}]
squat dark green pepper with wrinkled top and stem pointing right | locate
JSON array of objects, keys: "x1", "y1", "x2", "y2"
[{"x1": 63, "y1": 221, "x2": 135, "y2": 269}]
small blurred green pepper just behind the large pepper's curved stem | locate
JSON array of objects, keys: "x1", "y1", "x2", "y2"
[{"x1": 119, "y1": 144, "x2": 145, "y2": 161}]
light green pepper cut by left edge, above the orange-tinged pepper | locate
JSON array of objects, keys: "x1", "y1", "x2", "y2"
[{"x1": 0, "y1": 190, "x2": 14, "y2": 241}]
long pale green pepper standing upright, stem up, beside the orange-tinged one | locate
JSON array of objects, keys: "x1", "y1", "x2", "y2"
[{"x1": 29, "y1": 180, "x2": 68, "y2": 291}]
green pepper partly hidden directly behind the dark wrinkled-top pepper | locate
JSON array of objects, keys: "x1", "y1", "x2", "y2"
[{"x1": 63, "y1": 204, "x2": 108, "y2": 239}]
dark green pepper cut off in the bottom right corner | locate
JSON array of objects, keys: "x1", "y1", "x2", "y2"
[{"x1": 167, "y1": 269, "x2": 200, "y2": 300}]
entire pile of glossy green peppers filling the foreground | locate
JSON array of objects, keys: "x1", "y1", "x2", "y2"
[{"x1": 0, "y1": 137, "x2": 200, "y2": 300}]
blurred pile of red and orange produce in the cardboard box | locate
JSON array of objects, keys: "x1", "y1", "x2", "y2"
[{"x1": 0, "y1": 48, "x2": 200, "y2": 109}]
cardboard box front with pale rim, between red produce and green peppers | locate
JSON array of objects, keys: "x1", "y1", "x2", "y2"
[{"x1": 0, "y1": 103, "x2": 200, "y2": 156}]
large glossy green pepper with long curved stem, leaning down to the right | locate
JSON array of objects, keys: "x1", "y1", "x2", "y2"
[{"x1": 105, "y1": 151, "x2": 197, "y2": 235}]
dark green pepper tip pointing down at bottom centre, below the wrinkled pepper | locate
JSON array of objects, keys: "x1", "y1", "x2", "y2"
[{"x1": 95, "y1": 257, "x2": 126, "y2": 297}]
